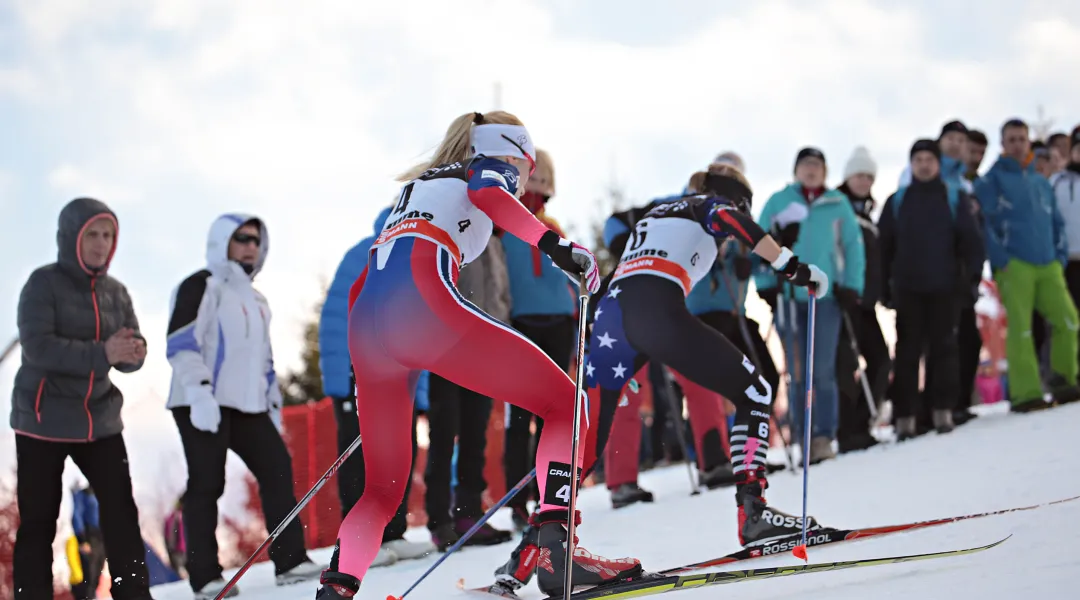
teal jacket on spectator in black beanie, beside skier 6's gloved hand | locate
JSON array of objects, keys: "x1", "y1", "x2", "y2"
[{"x1": 754, "y1": 183, "x2": 866, "y2": 302}]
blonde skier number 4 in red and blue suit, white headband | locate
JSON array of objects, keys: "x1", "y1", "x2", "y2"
[{"x1": 318, "y1": 111, "x2": 642, "y2": 599}]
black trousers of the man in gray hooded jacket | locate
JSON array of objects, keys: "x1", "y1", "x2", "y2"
[{"x1": 12, "y1": 434, "x2": 150, "y2": 600}]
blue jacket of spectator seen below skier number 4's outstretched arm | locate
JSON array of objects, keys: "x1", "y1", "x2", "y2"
[{"x1": 502, "y1": 223, "x2": 576, "y2": 318}]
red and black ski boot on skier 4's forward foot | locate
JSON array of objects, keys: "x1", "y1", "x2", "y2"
[{"x1": 535, "y1": 510, "x2": 644, "y2": 597}]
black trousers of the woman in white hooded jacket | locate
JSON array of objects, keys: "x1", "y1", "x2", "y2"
[{"x1": 173, "y1": 407, "x2": 308, "y2": 590}]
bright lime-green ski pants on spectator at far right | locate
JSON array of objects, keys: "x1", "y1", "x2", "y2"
[{"x1": 994, "y1": 258, "x2": 1078, "y2": 403}]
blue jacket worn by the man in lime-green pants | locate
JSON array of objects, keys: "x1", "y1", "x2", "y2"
[{"x1": 975, "y1": 156, "x2": 1069, "y2": 269}]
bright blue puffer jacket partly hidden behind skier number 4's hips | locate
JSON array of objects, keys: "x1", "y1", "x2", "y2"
[{"x1": 319, "y1": 207, "x2": 429, "y2": 410}]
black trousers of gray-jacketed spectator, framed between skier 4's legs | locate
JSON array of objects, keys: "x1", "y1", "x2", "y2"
[{"x1": 423, "y1": 373, "x2": 491, "y2": 531}]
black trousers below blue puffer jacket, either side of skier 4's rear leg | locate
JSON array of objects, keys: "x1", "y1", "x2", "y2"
[{"x1": 333, "y1": 397, "x2": 417, "y2": 544}]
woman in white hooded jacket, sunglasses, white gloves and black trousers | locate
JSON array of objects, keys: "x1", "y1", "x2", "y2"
[{"x1": 166, "y1": 214, "x2": 323, "y2": 599}]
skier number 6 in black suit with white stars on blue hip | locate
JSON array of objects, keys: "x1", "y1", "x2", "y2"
[{"x1": 496, "y1": 164, "x2": 828, "y2": 589}]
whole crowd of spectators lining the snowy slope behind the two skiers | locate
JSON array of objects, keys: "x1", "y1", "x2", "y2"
[{"x1": 11, "y1": 114, "x2": 1080, "y2": 600}]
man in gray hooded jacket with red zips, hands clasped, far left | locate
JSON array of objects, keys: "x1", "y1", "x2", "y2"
[{"x1": 11, "y1": 197, "x2": 150, "y2": 600}]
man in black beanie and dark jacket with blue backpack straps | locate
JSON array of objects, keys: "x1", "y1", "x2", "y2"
[{"x1": 878, "y1": 139, "x2": 984, "y2": 440}]
